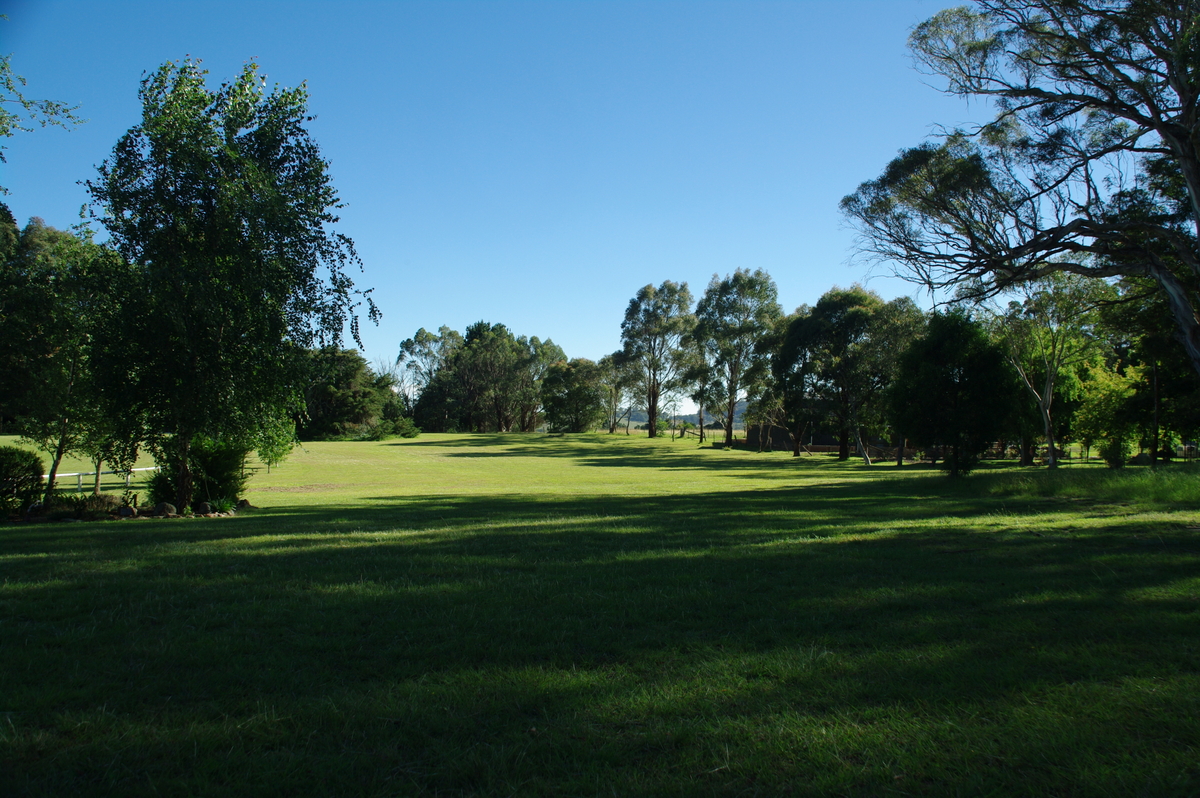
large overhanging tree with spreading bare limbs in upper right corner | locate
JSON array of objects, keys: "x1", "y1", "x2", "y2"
[{"x1": 841, "y1": 0, "x2": 1200, "y2": 373}]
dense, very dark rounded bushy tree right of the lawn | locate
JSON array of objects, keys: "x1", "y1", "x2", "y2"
[{"x1": 888, "y1": 312, "x2": 1021, "y2": 476}]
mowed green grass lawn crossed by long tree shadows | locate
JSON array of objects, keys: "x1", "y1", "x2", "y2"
[{"x1": 0, "y1": 434, "x2": 1200, "y2": 796}]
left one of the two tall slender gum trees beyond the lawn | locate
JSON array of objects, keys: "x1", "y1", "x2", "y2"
[{"x1": 620, "y1": 280, "x2": 695, "y2": 438}]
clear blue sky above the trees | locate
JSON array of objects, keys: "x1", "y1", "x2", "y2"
[{"x1": 0, "y1": 0, "x2": 986, "y2": 361}]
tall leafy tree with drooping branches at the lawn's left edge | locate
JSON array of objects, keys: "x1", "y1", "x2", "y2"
[{"x1": 88, "y1": 61, "x2": 378, "y2": 506}]
